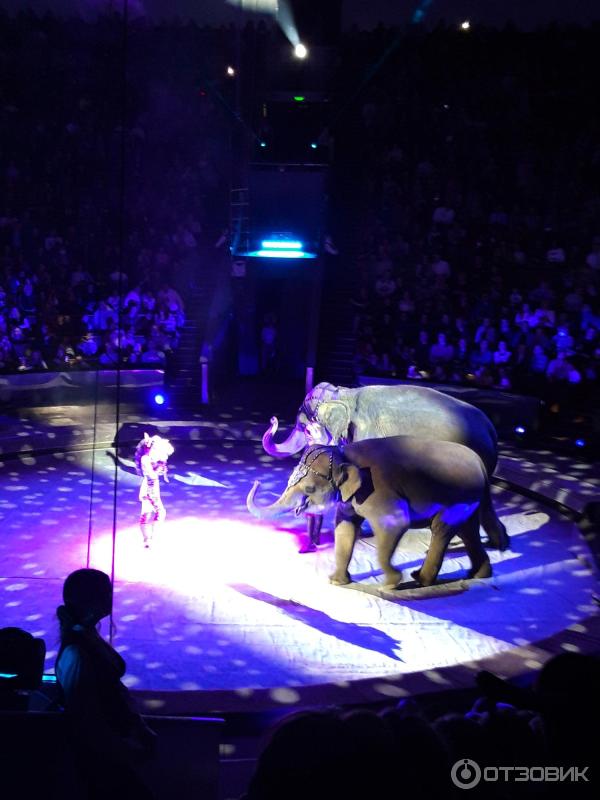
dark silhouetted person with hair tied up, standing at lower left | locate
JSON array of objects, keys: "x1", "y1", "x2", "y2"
[{"x1": 56, "y1": 569, "x2": 155, "y2": 800}]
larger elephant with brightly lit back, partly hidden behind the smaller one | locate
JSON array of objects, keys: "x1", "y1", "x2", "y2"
[{"x1": 262, "y1": 383, "x2": 509, "y2": 550}]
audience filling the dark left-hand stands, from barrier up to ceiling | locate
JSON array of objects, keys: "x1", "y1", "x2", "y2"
[{"x1": 0, "y1": 12, "x2": 228, "y2": 372}]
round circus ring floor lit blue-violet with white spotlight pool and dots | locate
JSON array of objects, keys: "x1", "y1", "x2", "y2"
[{"x1": 0, "y1": 390, "x2": 600, "y2": 713}]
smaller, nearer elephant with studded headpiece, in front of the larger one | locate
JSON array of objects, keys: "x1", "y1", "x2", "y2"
[{"x1": 246, "y1": 436, "x2": 492, "y2": 586}]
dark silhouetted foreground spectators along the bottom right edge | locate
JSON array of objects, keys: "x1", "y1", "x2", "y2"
[{"x1": 243, "y1": 653, "x2": 600, "y2": 800}]
